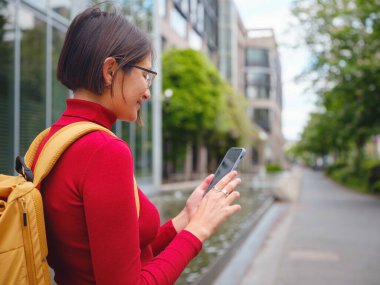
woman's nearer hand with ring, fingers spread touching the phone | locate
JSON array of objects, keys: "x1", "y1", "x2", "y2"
[{"x1": 185, "y1": 171, "x2": 241, "y2": 242}]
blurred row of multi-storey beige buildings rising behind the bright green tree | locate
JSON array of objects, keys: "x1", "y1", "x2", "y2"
[{"x1": 160, "y1": 0, "x2": 284, "y2": 170}]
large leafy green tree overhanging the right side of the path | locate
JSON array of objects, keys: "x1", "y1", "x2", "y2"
[{"x1": 292, "y1": 0, "x2": 380, "y2": 168}]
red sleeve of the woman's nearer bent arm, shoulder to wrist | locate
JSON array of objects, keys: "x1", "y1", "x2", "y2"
[{"x1": 81, "y1": 138, "x2": 202, "y2": 285}]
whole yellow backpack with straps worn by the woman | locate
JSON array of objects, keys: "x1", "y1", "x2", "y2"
[{"x1": 0, "y1": 122, "x2": 140, "y2": 285}]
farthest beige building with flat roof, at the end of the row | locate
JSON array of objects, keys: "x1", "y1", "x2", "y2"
[{"x1": 244, "y1": 29, "x2": 284, "y2": 165}]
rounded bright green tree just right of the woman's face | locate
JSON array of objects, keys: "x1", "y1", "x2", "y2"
[{"x1": 163, "y1": 49, "x2": 226, "y2": 143}]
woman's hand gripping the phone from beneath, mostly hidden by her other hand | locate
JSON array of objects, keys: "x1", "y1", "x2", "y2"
[{"x1": 172, "y1": 174, "x2": 214, "y2": 233}]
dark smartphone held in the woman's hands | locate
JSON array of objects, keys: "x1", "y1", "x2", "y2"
[{"x1": 207, "y1": 147, "x2": 245, "y2": 191}]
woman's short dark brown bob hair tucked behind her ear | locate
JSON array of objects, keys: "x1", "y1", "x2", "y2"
[{"x1": 57, "y1": 6, "x2": 153, "y2": 95}]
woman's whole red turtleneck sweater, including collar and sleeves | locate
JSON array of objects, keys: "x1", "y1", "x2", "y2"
[{"x1": 33, "y1": 99, "x2": 202, "y2": 285}]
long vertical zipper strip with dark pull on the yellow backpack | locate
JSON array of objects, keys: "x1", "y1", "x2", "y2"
[{"x1": 20, "y1": 197, "x2": 36, "y2": 284}]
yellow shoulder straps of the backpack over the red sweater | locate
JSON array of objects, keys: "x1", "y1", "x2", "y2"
[{"x1": 26, "y1": 122, "x2": 140, "y2": 217}]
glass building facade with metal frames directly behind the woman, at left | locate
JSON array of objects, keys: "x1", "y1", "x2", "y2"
[{"x1": 0, "y1": 0, "x2": 159, "y2": 189}]
